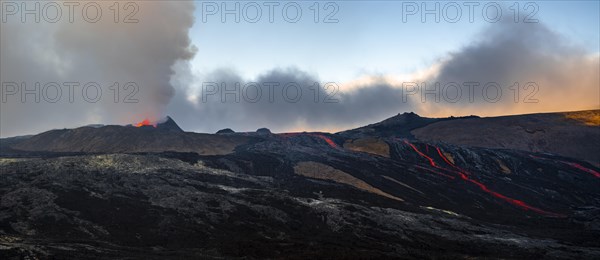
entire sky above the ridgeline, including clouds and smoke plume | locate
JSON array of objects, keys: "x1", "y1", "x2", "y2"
[{"x1": 0, "y1": 1, "x2": 600, "y2": 137}]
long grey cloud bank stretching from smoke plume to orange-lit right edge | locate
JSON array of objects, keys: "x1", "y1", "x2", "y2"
[{"x1": 169, "y1": 15, "x2": 600, "y2": 132}]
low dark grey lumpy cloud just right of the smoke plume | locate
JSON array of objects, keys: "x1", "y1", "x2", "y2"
[{"x1": 169, "y1": 68, "x2": 409, "y2": 132}]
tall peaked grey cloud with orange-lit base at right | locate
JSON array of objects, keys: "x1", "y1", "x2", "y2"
[{"x1": 417, "y1": 19, "x2": 600, "y2": 116}]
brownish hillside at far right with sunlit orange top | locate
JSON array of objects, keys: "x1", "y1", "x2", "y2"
[{"x1": 411, "y1": 110, "x2": 600, "y2": 166}]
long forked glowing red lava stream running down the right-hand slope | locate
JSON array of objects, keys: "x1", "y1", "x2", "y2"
[{"x1": 404, "y1": 140, "x2": 568, "y2": 217}]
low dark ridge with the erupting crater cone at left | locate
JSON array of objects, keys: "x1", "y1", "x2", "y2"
[{"x1": 3, "y1": 117, "x2": 252, "y2": 155}]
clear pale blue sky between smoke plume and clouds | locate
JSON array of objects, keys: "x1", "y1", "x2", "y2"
[{"x1": 190, "y1": 1, "x2": 600, "y2": 81}]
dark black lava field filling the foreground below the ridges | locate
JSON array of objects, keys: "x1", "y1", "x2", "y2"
[{"x1": 0, "y1": 136, "x2": 600, "y2": 259}]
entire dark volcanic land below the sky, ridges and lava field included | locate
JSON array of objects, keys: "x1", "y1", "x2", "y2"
[{"x1": 0, "y1": 111, "x2": 600, "y2": 259}]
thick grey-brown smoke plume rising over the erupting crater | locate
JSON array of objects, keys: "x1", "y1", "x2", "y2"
[{"x1": 0, "y1": 1, "x2": 194, "y2": 137}]
